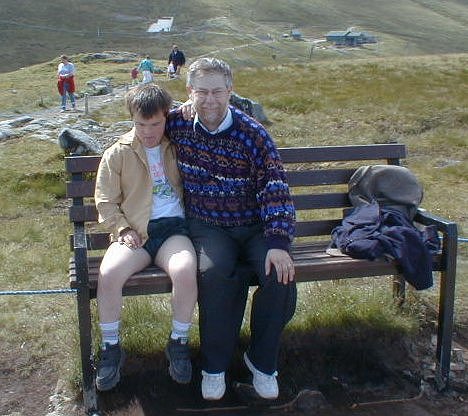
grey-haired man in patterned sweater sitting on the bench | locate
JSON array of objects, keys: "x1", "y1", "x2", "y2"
[{"x1": 167, "y1": 58, "x2": 297, "y2": 400}]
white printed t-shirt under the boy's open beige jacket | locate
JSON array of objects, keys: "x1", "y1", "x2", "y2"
[{"x1": 145, "y1": 146, "x2": 184, "y2": 220}]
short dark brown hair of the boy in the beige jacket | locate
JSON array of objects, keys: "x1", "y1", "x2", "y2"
[{"x1": 125, "y1": 84, "x2": 172, "y2": 118}]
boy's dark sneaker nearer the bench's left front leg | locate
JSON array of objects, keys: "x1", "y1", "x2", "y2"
[{"x1": 96, "y1": 343, "x2": 125, "y2": 391}]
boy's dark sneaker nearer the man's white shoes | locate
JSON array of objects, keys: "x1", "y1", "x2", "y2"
[{"x1": 166, "y1": 338, "x2": 192, "y2": 384}]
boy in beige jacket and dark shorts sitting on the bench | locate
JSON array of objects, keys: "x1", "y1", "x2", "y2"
[{"x1": 94, "y1": 84, "x2": 197, "y2": 391}]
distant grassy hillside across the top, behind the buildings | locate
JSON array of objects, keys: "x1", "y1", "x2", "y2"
[{"x1": 0, "y1": 0, "x2": 468, "y2": 72}]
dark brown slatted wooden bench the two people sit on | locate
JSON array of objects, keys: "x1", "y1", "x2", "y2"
[{"x1": 65, "y1": 144, "x2": 457, "y2": 413}]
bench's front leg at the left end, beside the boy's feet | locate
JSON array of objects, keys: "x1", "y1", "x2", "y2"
[{"x1": 77, "y1": 286, "x2": 98, "y2": 415}]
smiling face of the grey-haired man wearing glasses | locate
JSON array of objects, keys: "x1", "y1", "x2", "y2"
[{"x1": 188, "y1": 74, "x2": 232, "y2": 130}]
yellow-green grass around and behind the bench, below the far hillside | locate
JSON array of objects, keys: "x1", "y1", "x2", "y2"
[{"x1": 0, "y1": 54, "x2": 468, "y2": 400}]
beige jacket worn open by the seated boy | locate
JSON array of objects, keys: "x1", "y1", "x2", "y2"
[{"x1": 94, "y1": 129, "x2": 182, "y2": 242}]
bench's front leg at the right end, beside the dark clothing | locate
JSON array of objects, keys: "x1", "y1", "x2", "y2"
[{"x1": 436, "y1": 226, "x2": 457, "y2": 390}]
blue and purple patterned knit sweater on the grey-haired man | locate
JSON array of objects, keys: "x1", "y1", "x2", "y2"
[{"x1": 166, "y1": 107, "x2": 295, "y2": 250}]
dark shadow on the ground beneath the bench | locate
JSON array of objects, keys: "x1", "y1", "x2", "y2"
[{"x1": 99, "y1": 328, "x2": 428, "y2": 416}]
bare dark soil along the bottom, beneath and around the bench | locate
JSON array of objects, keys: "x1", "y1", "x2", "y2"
[{"x1": 0, "y1": 324, "x2": 468, "y2": 416}]
